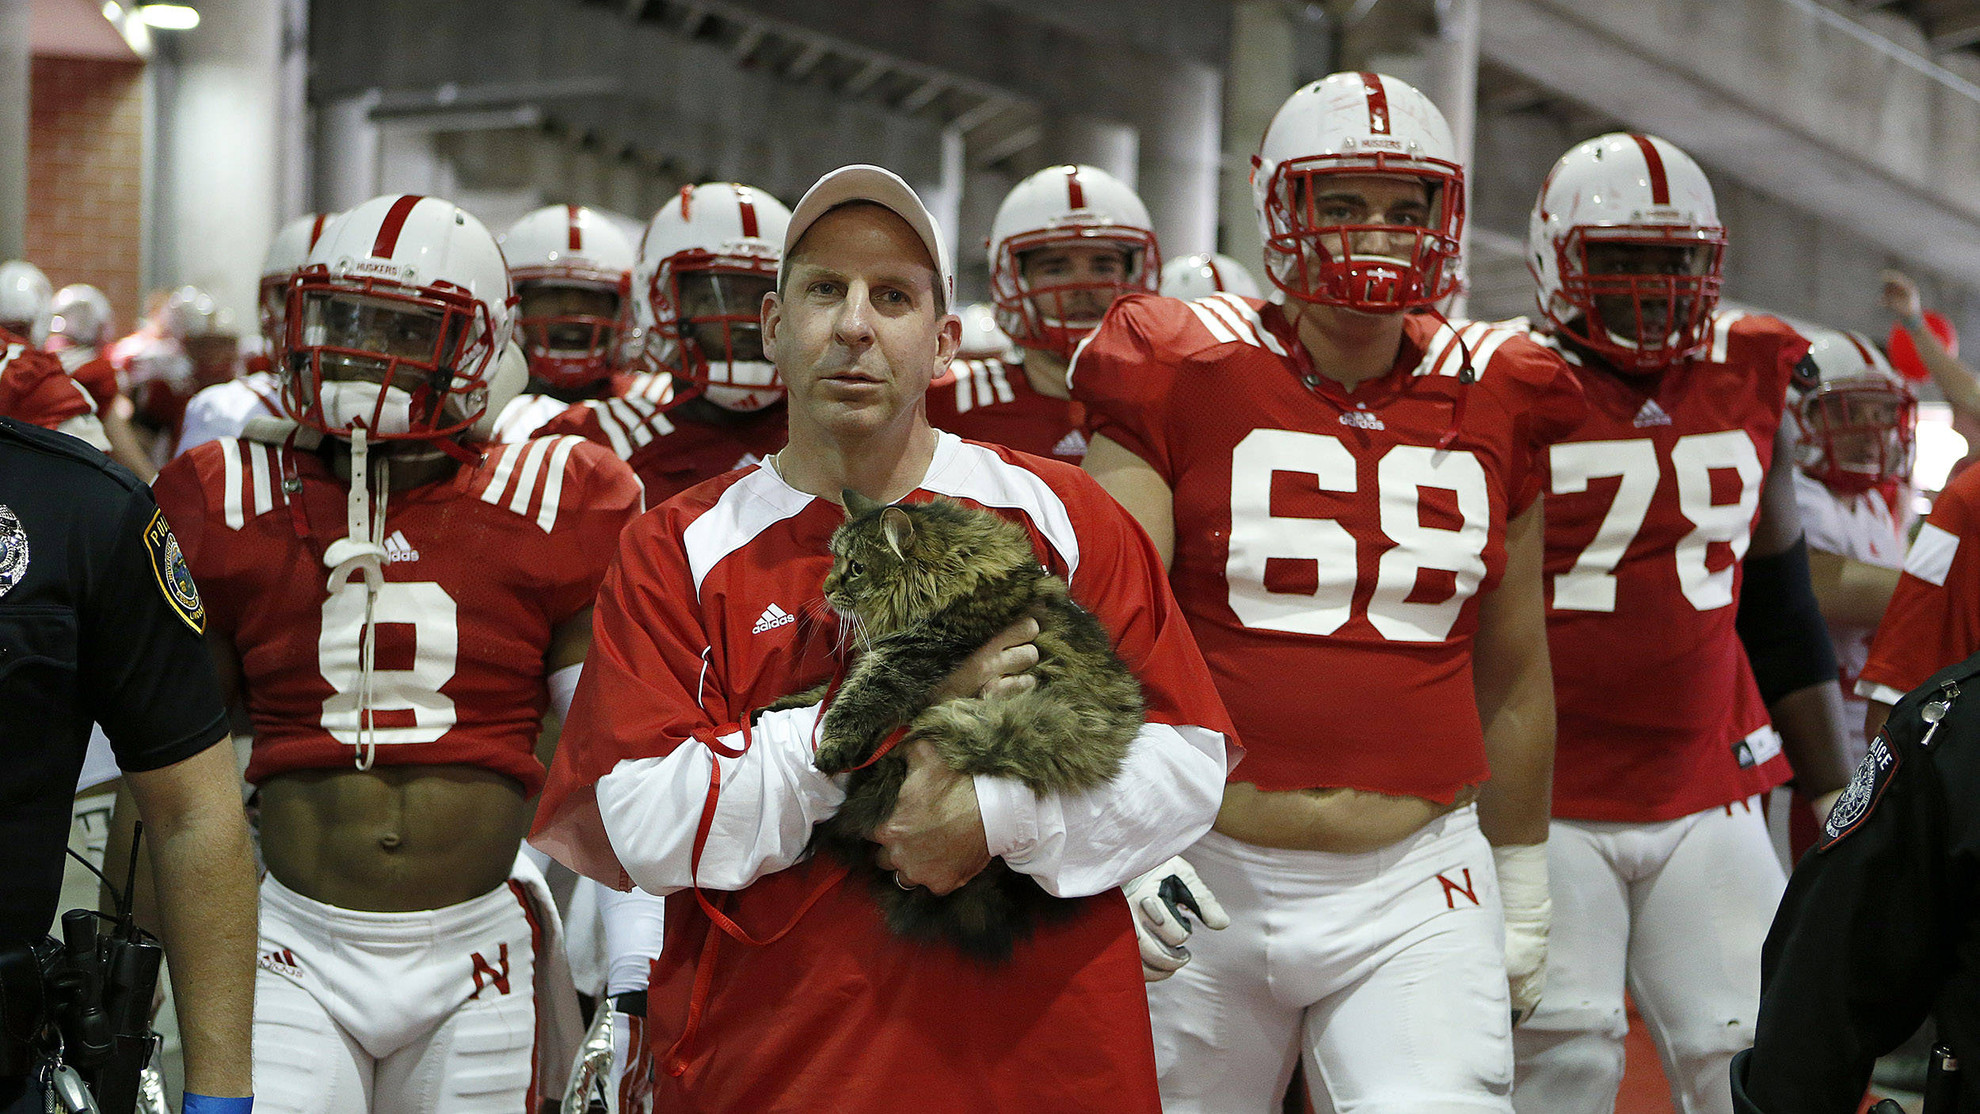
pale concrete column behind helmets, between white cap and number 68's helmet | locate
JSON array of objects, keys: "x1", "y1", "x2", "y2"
[{"x1": 1129, "y1": 59, "x2": 1224, "y2": 259}]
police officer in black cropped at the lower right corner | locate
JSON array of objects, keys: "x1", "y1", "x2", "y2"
[{"x1": 1733, "y1": 655, "x2": 1980, "y2": 1114}]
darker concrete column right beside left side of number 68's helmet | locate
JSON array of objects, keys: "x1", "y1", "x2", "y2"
[{"x1": 1219, "y1": 0, "x2": 1297, "y2": 281}]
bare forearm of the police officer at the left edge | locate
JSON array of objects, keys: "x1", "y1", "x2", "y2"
[{"x1": 147, "y1": 791, "x2": 255, "y2": 1096}]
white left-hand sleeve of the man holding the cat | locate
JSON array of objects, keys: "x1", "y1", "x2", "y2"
[{"x1": 596, "y1": 704, "x2": 845, "y2": 894}]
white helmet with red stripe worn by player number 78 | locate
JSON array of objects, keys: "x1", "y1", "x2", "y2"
[{"x1": 1527, "y1": 133, "x2": 1727, "y2": 372}]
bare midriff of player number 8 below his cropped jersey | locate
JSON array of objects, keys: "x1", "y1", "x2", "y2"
[{"x1": 261, "y1": 766, "x2": 529, "y2": 912}]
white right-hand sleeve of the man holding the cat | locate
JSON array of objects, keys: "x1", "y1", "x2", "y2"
[{"x1": 976, "y1": 724, "x2": 1228, "y2": 896}]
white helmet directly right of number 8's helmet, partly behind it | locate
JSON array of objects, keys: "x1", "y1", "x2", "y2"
[{"x1": 501, "y1": 206, "x2": 638, "y2": 388}]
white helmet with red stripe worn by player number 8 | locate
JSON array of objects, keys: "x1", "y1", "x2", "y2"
[{"x1": 283, "y1": 194, "x2": 515, "y2": 441}]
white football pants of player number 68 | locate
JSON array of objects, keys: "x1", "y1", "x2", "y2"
[{"x1": 1148, "y1": 807, "x2": 1513, "y2": 1114}]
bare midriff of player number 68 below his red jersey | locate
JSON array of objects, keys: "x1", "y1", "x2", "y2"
[{"x1": 1216, "y1": 782, "x2": 1477, "y2": 855}]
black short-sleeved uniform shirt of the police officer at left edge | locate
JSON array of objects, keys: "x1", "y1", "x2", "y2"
[{"x1": 0, "y1": 418, "x2": 228, "y2": 946}]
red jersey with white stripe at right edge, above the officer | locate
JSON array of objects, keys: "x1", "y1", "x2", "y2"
[{"x1": 1857, "y1": 469, "x2": 1980, "y2": 704}]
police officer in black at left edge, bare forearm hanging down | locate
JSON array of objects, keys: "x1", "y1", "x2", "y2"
[{"x1": 0, "y1": 418, "x2": 255, "y2": 1114}]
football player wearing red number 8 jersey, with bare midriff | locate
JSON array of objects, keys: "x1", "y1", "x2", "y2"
[{"x1": 156, "y1": 196, "x2": 640, "y2": 1112}]
